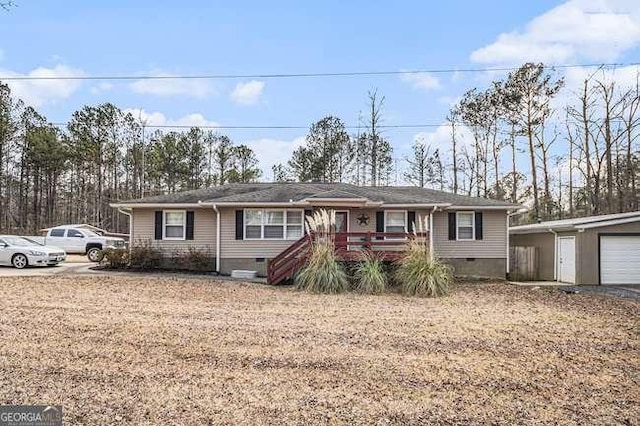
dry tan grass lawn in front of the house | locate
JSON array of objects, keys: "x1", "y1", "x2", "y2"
[{"x1": 0, "y1": 276, "x2": 640, "y2": 425}]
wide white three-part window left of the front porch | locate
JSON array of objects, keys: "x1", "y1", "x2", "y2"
[{"x1": 244, "y1": 209, "x2": 303, "y2": 240}]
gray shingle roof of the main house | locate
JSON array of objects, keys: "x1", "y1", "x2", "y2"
[{"x1": 119, "y1": 183, "x2": 520, "y2": 208}]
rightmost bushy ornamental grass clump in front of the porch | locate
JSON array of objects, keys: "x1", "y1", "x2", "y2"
[{"x1": 395, "y1": 238, "x2": 453, "y2": 297}]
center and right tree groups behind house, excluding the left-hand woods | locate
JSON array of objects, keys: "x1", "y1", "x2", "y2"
[{"x1": 274, "y1": 63, "x2": 640, "y2": 221}]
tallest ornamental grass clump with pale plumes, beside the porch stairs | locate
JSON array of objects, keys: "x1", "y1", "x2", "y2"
[{"x1": 294, "y1": 210, "x2": 349, "y2": 294}]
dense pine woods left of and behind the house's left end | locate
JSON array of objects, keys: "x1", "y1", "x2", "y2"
[{"x1": 0, "y1": 83, "x2": 262, "y2": 233}]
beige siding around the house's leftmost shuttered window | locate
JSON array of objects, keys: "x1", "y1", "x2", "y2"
[{"x1": 131, "y1": 208, "x2": 216, "y2": 256}]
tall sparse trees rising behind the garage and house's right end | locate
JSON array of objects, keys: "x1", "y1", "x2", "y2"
[{"x1": 438, "y1": 63, "x2": 640, "y2": 221}]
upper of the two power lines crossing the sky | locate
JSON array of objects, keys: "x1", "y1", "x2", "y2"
[{"x1": 0, "y1": 62, "x2": 640, "y2": 81}]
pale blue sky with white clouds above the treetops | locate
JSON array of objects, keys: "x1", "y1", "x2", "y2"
[{"x1": 0, "y1": 0, "x2": 640, "y2": 176}]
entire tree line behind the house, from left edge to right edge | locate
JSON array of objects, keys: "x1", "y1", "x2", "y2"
[{"x1": 0, "y1": 63, "x2": 640, "y2": 233}]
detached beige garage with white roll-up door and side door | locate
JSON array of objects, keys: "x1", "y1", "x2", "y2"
[{"x1": 509, "y1": 212, "x2": 640, "y2": 285}]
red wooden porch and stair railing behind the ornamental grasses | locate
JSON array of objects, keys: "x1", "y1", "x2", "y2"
[{"x1": 267, "y1": 232, "x2": 429, "y2": 284}]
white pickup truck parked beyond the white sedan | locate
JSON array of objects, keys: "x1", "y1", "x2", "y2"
[{"x1": 27, "y1": 226, "x2": 125, "y2": 262}]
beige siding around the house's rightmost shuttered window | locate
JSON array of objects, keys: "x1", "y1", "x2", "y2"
[{"x1": 433, "y1": 210, "x2": 507, "y2": 258}]
